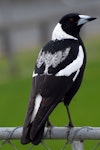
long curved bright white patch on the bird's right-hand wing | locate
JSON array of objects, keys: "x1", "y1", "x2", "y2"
[{"x1": 56, "y1": 45, "x2": 84, "y2": 81}]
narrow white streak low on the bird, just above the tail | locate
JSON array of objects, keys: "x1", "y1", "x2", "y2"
[{"x1": 31, "y1": 94, "x2": 42, "y2": 122}]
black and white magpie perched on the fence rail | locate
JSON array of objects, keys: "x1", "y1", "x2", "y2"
[{"x1": 21, "y1": 13, "x2": 96, "y2": 145}]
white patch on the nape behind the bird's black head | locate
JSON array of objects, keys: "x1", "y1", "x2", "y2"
[{"x1": 52, "y1": 23, "x2": 78, "y2": 41}]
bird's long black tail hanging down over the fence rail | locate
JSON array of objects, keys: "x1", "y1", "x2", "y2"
[{"x1": 21, "y1": 98, "x2": 58, "y2": 145}]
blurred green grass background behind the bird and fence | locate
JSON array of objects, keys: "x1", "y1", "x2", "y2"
[{"x1": 0, "y1": 37, "x2": 100, "y2": 150}]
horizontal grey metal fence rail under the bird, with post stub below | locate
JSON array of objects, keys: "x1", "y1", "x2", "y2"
[{"x1": 0, "y1": 126, "x2": 100, "y2": 150}]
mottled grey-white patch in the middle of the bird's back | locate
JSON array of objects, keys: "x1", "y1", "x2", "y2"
[{"x1": 37, "y1": 47, "x2": 70, "y2": 74}]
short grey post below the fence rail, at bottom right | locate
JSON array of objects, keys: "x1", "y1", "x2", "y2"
[{"x1": 72, "y1": 141, "x2": 84, "y2": 150}]
